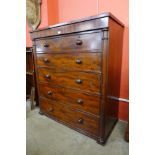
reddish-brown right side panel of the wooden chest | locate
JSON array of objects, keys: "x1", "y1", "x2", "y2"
[{"x1": 102, "y1": 19, "x2": 123, "y2": 140}]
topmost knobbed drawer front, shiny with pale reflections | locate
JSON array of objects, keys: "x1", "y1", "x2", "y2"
[{"x1": 36, "y1": 33, "x2": 102, "y2": 53}]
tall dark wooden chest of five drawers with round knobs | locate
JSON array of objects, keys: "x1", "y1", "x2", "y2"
[{"x1": 30, "y1": 13, "x2": 123, "y2": 144}]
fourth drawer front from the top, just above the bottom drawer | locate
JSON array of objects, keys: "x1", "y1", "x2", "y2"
[{"x1": 39, "y1": 83, "x2": 100, "y2": 115}]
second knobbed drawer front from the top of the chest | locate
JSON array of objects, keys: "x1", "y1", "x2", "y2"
[{"x1": 37, "y1": 52, "x2": 101, "y2": 72}]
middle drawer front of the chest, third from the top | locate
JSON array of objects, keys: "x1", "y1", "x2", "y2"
[{"x1": 38, "y1": 68, "x2": 101, "y2": 93}]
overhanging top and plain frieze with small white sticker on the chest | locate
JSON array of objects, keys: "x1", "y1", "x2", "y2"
[{"x1": 30, "y1": 12, "x2": 124, "y2": 40}]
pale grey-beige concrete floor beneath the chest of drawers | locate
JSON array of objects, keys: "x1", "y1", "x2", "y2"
[{"x1": 26, "y1": 101, "x2": 129, "y2": 155}]
